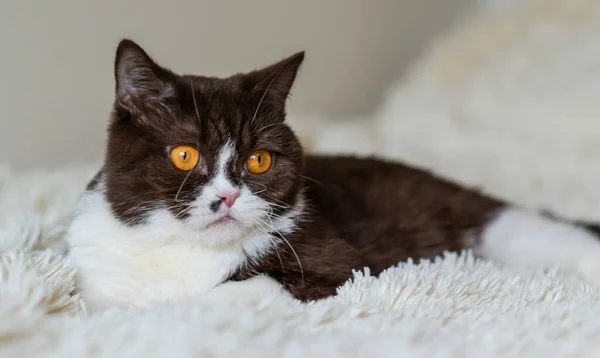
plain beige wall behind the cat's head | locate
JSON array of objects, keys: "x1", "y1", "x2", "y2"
[{"x1": 0, "y1": 0, "x2": 474, "y2": 167}]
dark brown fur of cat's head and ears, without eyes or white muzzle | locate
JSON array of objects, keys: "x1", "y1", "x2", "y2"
[{"x1": 104, "y1": 40, "x2": 304, "y2": 224}]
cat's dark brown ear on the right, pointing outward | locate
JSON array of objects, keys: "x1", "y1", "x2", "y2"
[{"x1": 248, "y1": 51, "x2": 304, "y2": 108}]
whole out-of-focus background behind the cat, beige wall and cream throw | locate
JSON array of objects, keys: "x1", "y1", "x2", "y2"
[{"x1": 0, "y1": 0, "x2": 600, "y2": 219}]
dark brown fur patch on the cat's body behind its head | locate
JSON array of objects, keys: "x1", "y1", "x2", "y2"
[{"x1": 235, "y1": 156, "x2": 502, "y2": 300}]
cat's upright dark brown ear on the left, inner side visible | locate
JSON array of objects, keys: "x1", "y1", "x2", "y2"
[{"x1": 115, "y1": 39, "x2": 174, "y2": 113}]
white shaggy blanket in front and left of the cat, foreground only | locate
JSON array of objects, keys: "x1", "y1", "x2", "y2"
[{"x1": 0, "y1": 168, "x2": 600, "y2": 357}]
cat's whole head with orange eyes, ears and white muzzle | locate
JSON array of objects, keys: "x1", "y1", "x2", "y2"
[{"x1": 104, "y1": 41, "x2": 304, "y2": 246}]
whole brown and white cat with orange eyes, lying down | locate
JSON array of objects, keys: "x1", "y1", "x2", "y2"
[{"x1": 68, "y1": 40, "x2": 600, "y2": 309}]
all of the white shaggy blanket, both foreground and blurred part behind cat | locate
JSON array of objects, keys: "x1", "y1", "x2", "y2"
[{"x1": 0, "y1": 0, "x2": 600, "y2": 358}]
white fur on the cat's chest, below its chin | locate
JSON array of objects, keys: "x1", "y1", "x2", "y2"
[{"x1": 68, "y1": 186, "x2": 282, "y2": 310}]
